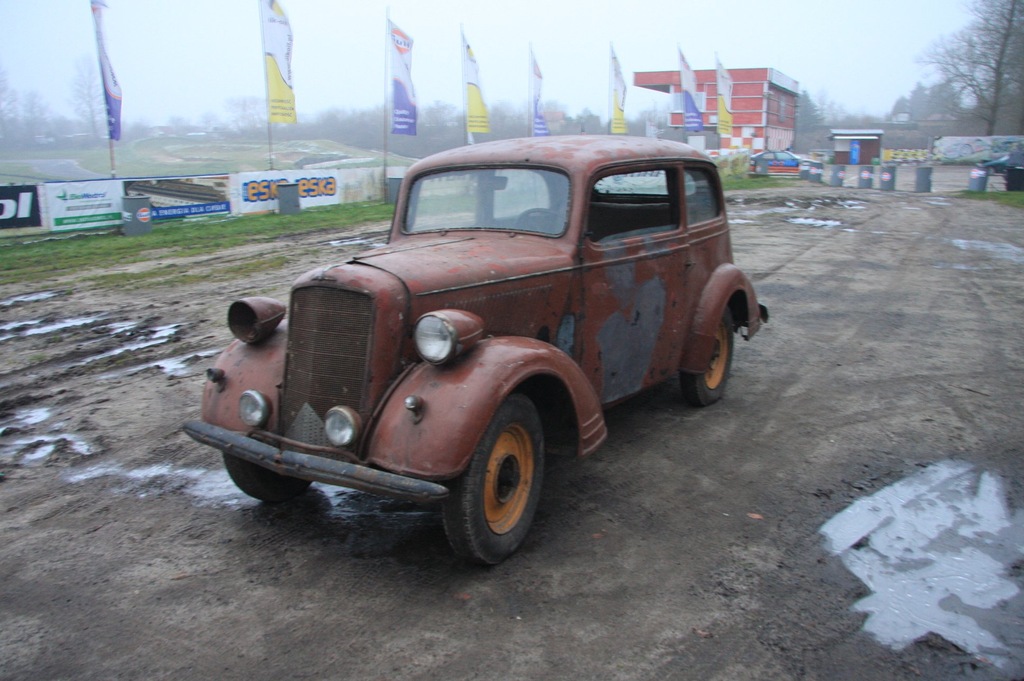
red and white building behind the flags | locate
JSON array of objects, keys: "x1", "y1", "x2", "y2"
[{"x1": 633, "y1": 69, "x2": 800, "y2": 153}]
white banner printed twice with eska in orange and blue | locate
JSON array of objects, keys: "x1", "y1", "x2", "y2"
[{"x1": 231, "y1": 168, "x2": 341, "y2": 213}]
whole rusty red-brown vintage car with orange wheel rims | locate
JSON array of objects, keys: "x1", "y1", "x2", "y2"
[{"x1": 185, "y1": 136, "x2": 768, "y2": 564}]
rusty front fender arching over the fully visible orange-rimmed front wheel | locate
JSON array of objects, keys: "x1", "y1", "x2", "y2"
[{"x1": 367, "y1": 337, "x2": 607, "y2": 480}]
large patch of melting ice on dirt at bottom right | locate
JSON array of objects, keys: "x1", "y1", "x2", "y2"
[{"x1": 820, "y1": 461, "x2": 1024, "y2": 674}]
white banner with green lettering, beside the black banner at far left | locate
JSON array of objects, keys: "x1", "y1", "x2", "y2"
[{"x1": 43, "y1": 179, "x2": 123, "y2": 231}]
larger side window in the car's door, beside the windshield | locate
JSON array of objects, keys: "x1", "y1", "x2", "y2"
[{"x1": 587, "y1": 169, "x2": 679, "y2": 242}]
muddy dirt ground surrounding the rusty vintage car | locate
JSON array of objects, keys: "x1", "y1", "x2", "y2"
[{"x1": 0, "y1": 173, "x2": 1024, "y2": 680}]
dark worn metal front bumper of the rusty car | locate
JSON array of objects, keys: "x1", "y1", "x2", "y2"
[{"x1": 184, "y1": 421, "x2": 449, "y2": 504}]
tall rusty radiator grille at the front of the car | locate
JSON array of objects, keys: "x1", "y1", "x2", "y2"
[{"x1": 281, "y1": 287, "x2": 373, "y2": 444}]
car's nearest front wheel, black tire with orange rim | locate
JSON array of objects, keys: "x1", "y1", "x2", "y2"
[{"x1": 443, "y1": 394, "x2": 544, "y2": 565}]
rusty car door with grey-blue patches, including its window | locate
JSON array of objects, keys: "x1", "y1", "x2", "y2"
[{"x1": 578, "y1": 163, "x2": 688, "y2": 405}]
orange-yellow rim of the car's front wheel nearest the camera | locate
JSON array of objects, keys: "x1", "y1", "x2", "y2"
[{"x1": 483, "y1": 423, "x2": 534, "y2": 535}]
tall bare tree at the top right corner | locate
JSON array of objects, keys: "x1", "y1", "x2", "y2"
[{"x1": 923, "y1": 0, "x2": 1024, "y2": 135}]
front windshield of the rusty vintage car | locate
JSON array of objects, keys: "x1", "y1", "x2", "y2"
[{"x1": 406, "y1": 168, "x2": 569, "y2": 236}]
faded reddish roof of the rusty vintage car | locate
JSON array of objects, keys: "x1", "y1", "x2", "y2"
[{"x1": 409, "y1": 135, "x2": 710, "y2": 174}]
